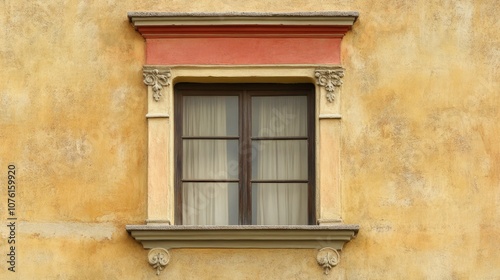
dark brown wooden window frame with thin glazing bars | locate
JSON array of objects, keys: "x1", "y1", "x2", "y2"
[{"x1": 174, "y1": 83, "x2": 316, "y2": 225}]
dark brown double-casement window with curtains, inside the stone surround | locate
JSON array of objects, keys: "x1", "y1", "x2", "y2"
[{"x1": 174, "y1": 83, "x2": 316, "y2": 225}]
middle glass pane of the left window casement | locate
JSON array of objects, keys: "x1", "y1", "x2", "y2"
[{"x1": 182, "y1": 139, "x2": 238, "y2": 180}]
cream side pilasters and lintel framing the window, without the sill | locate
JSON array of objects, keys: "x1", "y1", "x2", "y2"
[{"x1": 144, "y1": 65, "x2": 343, "y2": 225}]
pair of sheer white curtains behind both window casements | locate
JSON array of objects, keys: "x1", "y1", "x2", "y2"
[{"x1": 182, "y1": 96, "x2": 308, "y2": 225}]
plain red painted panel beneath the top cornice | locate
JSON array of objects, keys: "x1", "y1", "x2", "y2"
[{"x1": 146, "y1": 37, "x2": 341, "y2": 65}]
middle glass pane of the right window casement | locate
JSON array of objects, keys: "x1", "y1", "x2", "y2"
[{"x1": 252, "y1": 140, "x2": 307, "y2": 180}]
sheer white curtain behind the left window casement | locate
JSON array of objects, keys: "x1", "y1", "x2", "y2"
[{"x1": 182, "y1": 96, "x2": 229, "y2": 225}]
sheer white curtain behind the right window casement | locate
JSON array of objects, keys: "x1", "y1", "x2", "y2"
[{"x1": 252, "y1": 96, "x2": 308, "y2": 225}]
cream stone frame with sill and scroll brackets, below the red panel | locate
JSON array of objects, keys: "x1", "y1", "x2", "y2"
[{"x1": 126, "y1": 65, "x2": 359, "y2": 275}]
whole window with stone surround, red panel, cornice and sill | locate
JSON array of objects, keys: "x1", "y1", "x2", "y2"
[{"x1": 126, "y1": 11, "x2": 359, "y2": 274}]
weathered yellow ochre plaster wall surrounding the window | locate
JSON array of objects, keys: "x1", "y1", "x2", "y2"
[{"x1": 0, "y1": 0, "x2": 500, "y2": 279}]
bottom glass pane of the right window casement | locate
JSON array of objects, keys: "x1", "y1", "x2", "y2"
[{"x1": 252, "y1": 183, "x2": 308, "y2": 225}]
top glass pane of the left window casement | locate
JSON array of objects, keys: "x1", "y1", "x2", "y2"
[{"x1": 182, "y1": 96, "x2": 238, "y2": 136}]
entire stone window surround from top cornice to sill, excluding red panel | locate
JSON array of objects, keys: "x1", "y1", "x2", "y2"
[{"x1": 126, "y1": 11, "x2": 359, "y2": 274}]
